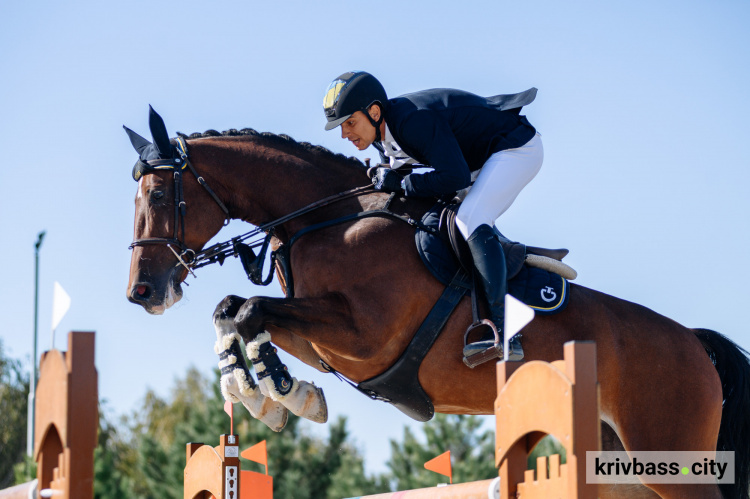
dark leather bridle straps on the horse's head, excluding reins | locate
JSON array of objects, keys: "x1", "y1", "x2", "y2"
[{"x1": 128, "y1": 137, "x2": 229, "y2": 276}]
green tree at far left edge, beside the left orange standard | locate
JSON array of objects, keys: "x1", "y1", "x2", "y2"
[{"x1": 0, "y1": 341, "x2": 29, "y2": 489}]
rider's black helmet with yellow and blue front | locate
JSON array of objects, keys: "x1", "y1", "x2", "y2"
[{"x1": 323, "y1": 71, "x2": 388, "y2": 130}]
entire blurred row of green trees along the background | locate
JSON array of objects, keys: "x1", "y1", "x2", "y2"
[{"x1": 0, "y1": 344, "x2": 564, "y2": 499}]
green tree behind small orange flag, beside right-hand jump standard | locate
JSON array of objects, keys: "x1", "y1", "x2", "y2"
[{"x1": 387, "y1": 414, "x2": 497, "y2": 490}]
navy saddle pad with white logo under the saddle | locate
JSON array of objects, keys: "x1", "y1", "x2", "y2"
[{"x1": 414, "y1": 204, "x2": 570, "y2": 315}]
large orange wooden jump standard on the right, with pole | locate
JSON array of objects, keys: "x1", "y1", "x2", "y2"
[{"x1": 352, "y1": 342, "x2": 600, "y2": 499}]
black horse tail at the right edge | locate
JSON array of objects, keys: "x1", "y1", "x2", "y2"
[{"x1": 693, "y1": 329, "x2": 750, "y2": 498}]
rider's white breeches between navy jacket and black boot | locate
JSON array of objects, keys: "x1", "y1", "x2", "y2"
[{"x1": 456, "y1": 133, "x2": 544, "y2": 239}]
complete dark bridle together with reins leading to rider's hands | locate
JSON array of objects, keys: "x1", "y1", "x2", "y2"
[{"x1": 128, "y1": 137, "x2": 373, "y2": 286}]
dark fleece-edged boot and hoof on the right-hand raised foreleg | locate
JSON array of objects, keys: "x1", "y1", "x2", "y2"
[{"x1": 246, "y1": 332, "x2": 328, "y2": 423}]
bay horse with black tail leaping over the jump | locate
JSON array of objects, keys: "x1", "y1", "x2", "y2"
[{"x1": 126, "y1": 110, "x2": 750, "y2": 498}]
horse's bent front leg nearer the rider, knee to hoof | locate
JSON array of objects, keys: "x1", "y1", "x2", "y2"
[{"x1": 217, "y1": 296, "x2": 328, "y2": 423}]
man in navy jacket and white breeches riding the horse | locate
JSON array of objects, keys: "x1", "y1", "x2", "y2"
[{"x1": 323, "y1": 71, "x2": 544, "y2": 360}]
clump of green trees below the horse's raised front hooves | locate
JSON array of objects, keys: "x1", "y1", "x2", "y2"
[{"x1": 95, "y1": 369, "x2": 387, "y2": 499}]
